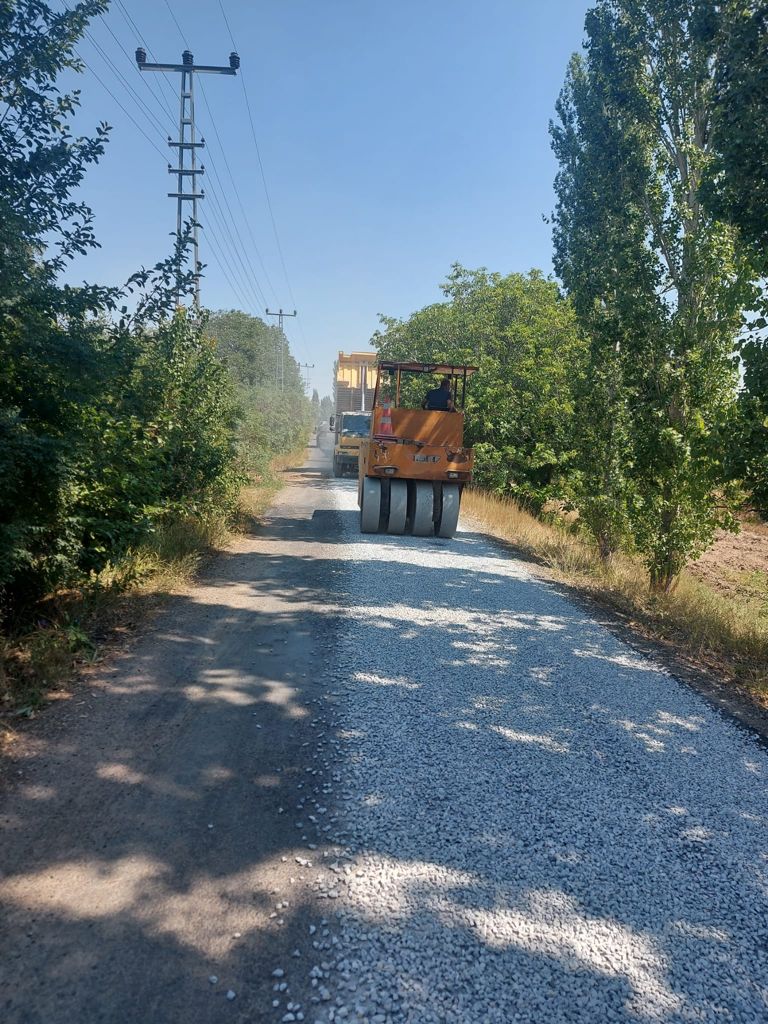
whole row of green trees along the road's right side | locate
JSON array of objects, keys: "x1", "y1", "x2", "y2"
[{"x1": 375, "y1": 0, "x2": 768, "y2": 591}]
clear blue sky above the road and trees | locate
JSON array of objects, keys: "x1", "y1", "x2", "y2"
[{"x1": 64, "y1": 0, "x2": 589, "y2": 394}]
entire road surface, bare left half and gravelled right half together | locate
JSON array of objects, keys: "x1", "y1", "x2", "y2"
[{"x1": 0, "y1": 456, "x2": 768, "y2": 1024}]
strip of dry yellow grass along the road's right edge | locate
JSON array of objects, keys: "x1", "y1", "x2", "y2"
[{"x1": 463, "y1": 490, "x2": 768, "y2": 707}]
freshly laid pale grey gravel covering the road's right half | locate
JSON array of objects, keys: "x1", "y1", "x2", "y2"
[{"x1": 290, "y1": 484, "x2": 768, "y2": 1024}]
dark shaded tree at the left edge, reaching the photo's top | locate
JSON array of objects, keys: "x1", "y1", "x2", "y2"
[{"x1": 0, "y1": 0, "x2": 115, "y2": 602}]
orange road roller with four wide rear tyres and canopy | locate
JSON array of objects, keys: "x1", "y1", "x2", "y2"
[{"x1": 357, "y1": 360, "x2": 477, "y2": 538}]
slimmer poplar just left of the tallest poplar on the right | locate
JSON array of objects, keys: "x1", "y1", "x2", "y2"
[{"x1": 550, "y1": 55, "x2": 654, "y2": 562}]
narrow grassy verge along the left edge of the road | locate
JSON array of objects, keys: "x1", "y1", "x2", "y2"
[{"x1": 0, "y1": 452, "x2": 304, "y2": 729}]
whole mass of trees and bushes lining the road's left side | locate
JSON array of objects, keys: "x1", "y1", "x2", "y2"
[{"x1": 0, "y1": 0, "x2": 311, "y2": 620}]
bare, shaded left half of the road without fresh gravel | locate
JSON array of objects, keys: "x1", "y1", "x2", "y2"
[{"x1": 0, "y1": 501, "x2": 342, "y2": 1024}]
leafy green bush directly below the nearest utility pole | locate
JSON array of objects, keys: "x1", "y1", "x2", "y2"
[{"x1": 74, "y1": 310, "x2": 240, "y2": 569}]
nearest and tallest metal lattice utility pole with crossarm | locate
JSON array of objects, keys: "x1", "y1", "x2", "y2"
[{"x1": 136, "y1": 46, "x2": 240, "y2": 309}]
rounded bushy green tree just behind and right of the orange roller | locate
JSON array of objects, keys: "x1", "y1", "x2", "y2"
[{"x1": 374, "y1": 264, "x2": 586, "y2": 508}]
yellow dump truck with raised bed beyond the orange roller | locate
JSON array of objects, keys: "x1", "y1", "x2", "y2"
[{"x1": 329, "y1": 352, "x2": 376, "y2": 476}]
